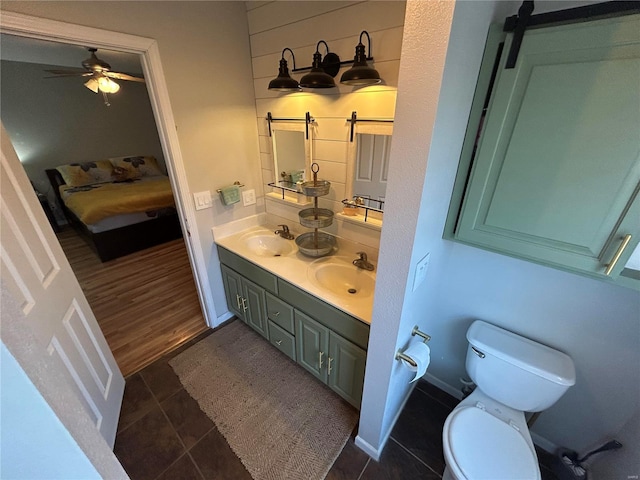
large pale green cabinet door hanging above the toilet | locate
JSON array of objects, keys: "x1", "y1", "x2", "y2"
[{"x1": 456, "y1": 15, "x2": 640, "y2": 277}]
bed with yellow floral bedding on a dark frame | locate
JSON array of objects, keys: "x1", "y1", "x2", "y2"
[{"x1": 45, "y1": 156, "x2": 182, "y2": 262}]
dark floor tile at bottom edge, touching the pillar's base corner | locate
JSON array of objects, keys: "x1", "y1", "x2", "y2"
[{"x1": 360, "y1": 439, "x2": 440, "y2": 480}]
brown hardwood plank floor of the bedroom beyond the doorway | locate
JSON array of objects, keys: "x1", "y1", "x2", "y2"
[{"x1": 57, "y1": 227, "x2": 208, "y2": 377}]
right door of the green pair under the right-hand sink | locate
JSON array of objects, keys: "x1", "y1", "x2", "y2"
[{"x1": 327, "y1": 332, "x2": 367, "y2": 408}]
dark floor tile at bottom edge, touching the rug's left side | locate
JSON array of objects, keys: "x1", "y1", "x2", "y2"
[{"x1": 189, "y1": 428, "x2": 251, "y2": 480}]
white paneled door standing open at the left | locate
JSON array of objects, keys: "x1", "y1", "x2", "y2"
[{"x1": 0, "y1": 125, "x2": 124, "y2": 447}]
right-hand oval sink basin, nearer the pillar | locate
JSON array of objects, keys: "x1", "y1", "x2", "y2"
[{"x1": 307, "y1": 257, "x2": 376, "y2": 299}]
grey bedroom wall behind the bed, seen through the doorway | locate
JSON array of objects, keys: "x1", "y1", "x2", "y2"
[{"x1": 0, "y1": 60, "x2": 166, "y2": 216}]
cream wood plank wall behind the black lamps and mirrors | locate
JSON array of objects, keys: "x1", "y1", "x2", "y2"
[{"x1": 246, "y1": 1, "x2": 405, "y2": 248}]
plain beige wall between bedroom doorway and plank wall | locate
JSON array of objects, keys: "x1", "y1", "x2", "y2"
[{"x1": 0, "y1": 1, "x2": 264, "y2": 322}]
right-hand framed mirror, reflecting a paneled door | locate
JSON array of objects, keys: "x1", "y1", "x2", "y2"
[{"x1": 344, "y1": 123, "x2": 393, "y2": 223}]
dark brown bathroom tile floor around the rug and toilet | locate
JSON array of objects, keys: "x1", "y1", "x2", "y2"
[{"x1": 114, "y1": 324, "x2": 556, "y2": 480}]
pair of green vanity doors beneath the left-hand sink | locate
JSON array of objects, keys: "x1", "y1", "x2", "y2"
[{"x1": 221, "y1": 265, "x2": 269, "y2": 338}]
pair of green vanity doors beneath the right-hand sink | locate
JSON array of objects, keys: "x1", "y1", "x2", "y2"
[{"x1": 295, "y1": 310, "x2": 367, "y2": 408}]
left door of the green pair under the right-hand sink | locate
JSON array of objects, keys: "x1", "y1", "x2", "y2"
[{"x1": 295, "y1": 310, "x2": 329, "y2": 383}]
